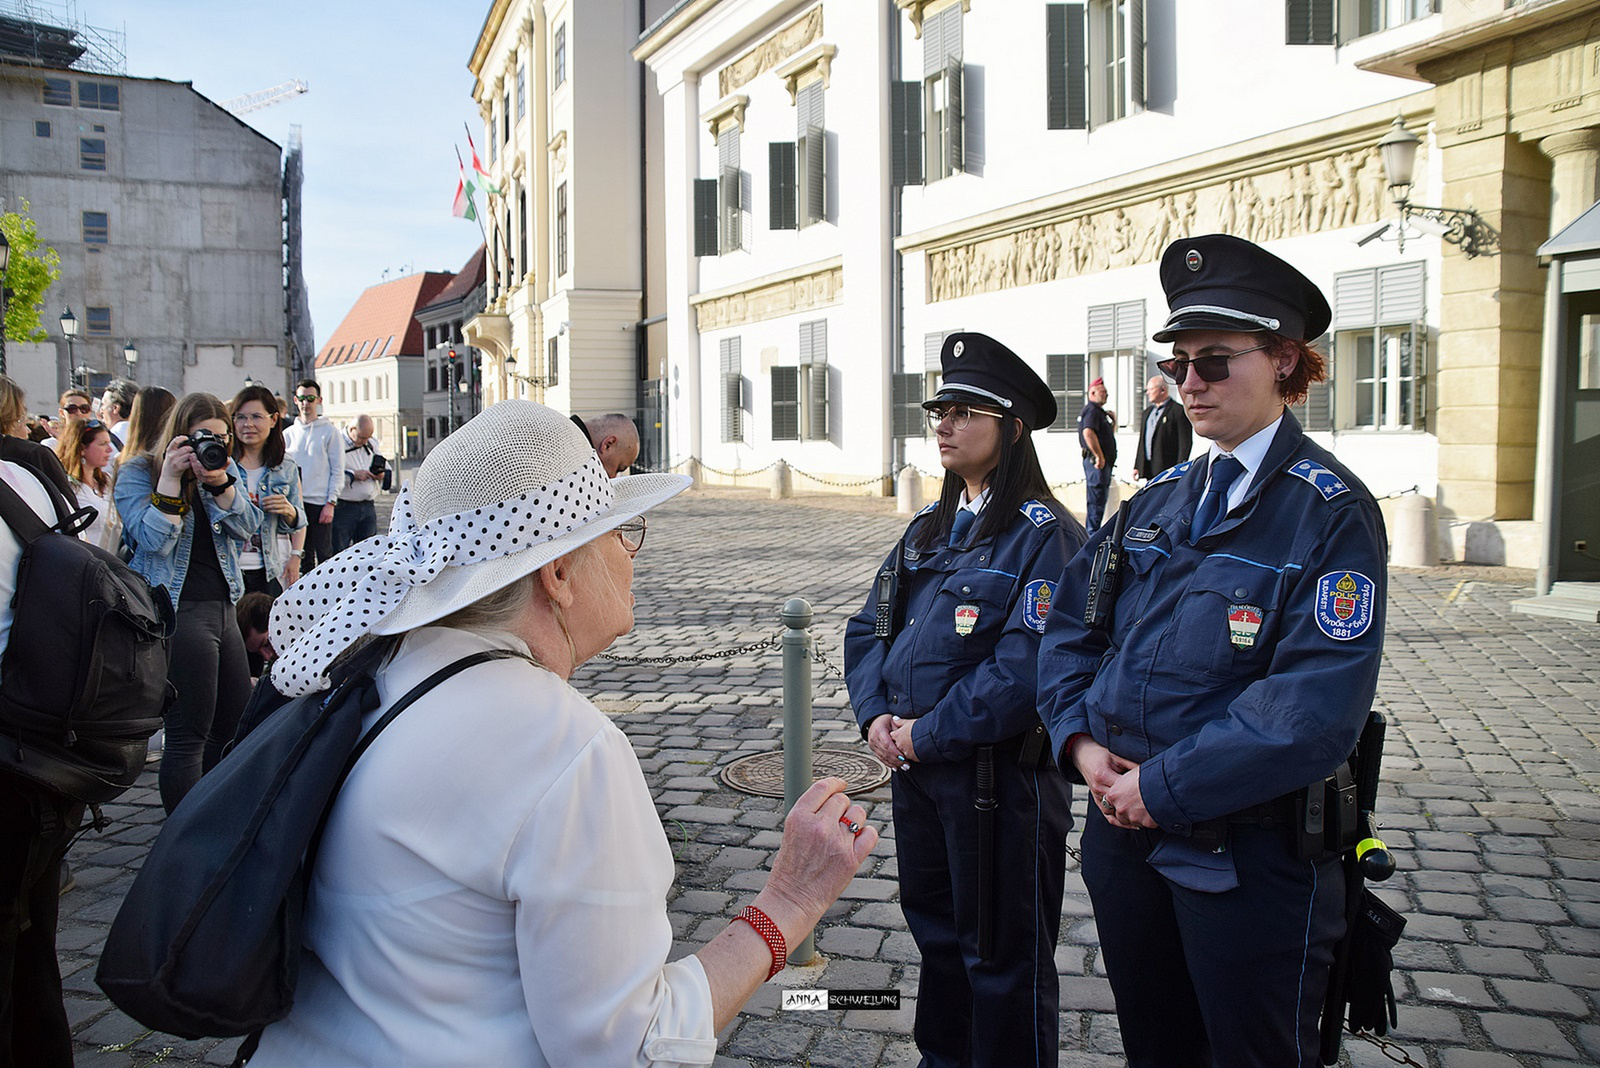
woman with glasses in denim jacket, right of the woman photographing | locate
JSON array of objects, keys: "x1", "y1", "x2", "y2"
[{"x1": 229, "y1": 385, "x2": 306, "y2": 596}]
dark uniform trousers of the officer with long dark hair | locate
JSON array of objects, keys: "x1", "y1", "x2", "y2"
[{"x1": 894, "y1": 747, "x2": 1072, "y2": 1068}]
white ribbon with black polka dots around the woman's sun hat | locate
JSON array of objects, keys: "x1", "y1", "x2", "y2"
[{"x1": 270, "y1": 452, "x2": 614, "y2": 697}]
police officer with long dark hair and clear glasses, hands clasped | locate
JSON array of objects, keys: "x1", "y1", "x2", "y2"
[{"x1": 845, "y1": 334, "x2": 1085, "y2": 1068}]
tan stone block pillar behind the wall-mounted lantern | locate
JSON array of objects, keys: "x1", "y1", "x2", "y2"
[{"x1": 1434, "y1": 131, "x2": 1550, "y2": 521}]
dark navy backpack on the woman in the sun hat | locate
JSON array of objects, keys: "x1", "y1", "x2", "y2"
[{"x1": 94, "y1": 641, "x2": 517, "y2": 1036}]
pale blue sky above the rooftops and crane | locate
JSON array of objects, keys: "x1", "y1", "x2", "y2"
[{"x1": 77, "y1": 0, "x2": 490, "y2": 347}]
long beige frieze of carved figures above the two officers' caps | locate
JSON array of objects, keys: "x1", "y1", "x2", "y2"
[{"x1": 926, "y1": 147, "x2": 1427, "y2": 302}]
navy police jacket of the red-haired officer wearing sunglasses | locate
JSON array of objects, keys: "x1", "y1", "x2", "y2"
[{"x1": 1038, "y1": 411, "x2": 1387, "y2": 891}]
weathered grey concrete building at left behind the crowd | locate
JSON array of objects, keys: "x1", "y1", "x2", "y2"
[{"x1": 0, "y1": 41, "x2": 288, "y2": 411}]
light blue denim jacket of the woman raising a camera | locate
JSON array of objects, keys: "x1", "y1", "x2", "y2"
[{"x1": 112, "y1": 457, "x2": 261, "y2": 609}]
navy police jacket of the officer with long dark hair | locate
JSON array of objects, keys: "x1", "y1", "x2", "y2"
[{"x1": 845, "y1": 500, "x2": 1077, "y2": 763}]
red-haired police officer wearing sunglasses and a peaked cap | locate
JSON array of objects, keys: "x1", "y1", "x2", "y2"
[{"x1": 1038, "y1": 235, "x2": 1387, "y2": 1068}]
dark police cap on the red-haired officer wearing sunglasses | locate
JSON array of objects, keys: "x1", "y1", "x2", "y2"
[{"x1": 1154, "y1": 233, "x2": 1333, "y2": 341}]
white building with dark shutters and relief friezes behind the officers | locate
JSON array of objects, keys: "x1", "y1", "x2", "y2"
[{"x1": 634, "y1": 0, "x2": 1600, "y2": 575}]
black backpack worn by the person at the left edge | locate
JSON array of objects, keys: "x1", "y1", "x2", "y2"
[{"x1": 0, "y1": 466, "x2": 174, "y2": 804}]
